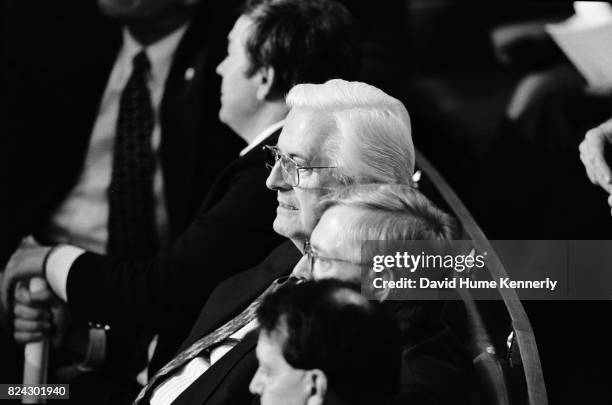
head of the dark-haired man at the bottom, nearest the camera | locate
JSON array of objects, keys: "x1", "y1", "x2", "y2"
[{"x1": 249, "y1": 280, "x2": 400, "y2": 405}]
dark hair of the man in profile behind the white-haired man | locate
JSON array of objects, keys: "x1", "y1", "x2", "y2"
[{"x1": 237, "y1": 0, "x2": 361, "y2": 98}]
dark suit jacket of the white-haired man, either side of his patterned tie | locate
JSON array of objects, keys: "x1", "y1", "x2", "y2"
[{"x1": 140, "y1": 241, "x2": 301, "y2": 405}]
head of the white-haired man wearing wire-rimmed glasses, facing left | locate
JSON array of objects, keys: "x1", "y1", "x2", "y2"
[{"x1": 266, "y1": 79, "x2": 414, "y2": 248}]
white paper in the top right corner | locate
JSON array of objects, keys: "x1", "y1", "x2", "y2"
[{"x1": 546, "y1": 1, "x2": 612, "y2": 90}]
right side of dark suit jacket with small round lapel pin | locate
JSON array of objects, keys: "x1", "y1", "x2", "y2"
[{"x1": 160, "y1": 0, "x2": 241, "y2": 237}]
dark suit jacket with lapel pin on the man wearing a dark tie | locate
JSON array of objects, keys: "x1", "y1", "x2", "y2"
[{"x1": 0, "y1": 0, "x2": 243, "y2": 263}]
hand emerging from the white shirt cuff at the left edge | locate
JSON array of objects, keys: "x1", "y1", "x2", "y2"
[{"x1": 1, "y1": 240, "x2": 51, "y2": 308}]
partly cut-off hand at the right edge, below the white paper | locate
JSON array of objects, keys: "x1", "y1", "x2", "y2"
[{"x1": 578, "y1": 119, "x2": 612, "y2": 194}]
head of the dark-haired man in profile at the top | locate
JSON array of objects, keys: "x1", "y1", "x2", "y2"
[{"x1": 217, "y1": 0, "x2": 360, "y2": 141}]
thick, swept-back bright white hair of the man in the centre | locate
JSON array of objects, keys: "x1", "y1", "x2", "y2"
[{"x1": 286, "y1": 79, "x2": 414, "y2": 184}]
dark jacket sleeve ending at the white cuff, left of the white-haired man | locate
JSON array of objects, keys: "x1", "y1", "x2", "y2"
[{"x1": 67, "y1": 159, "x2": 282, "y2": 330}]
